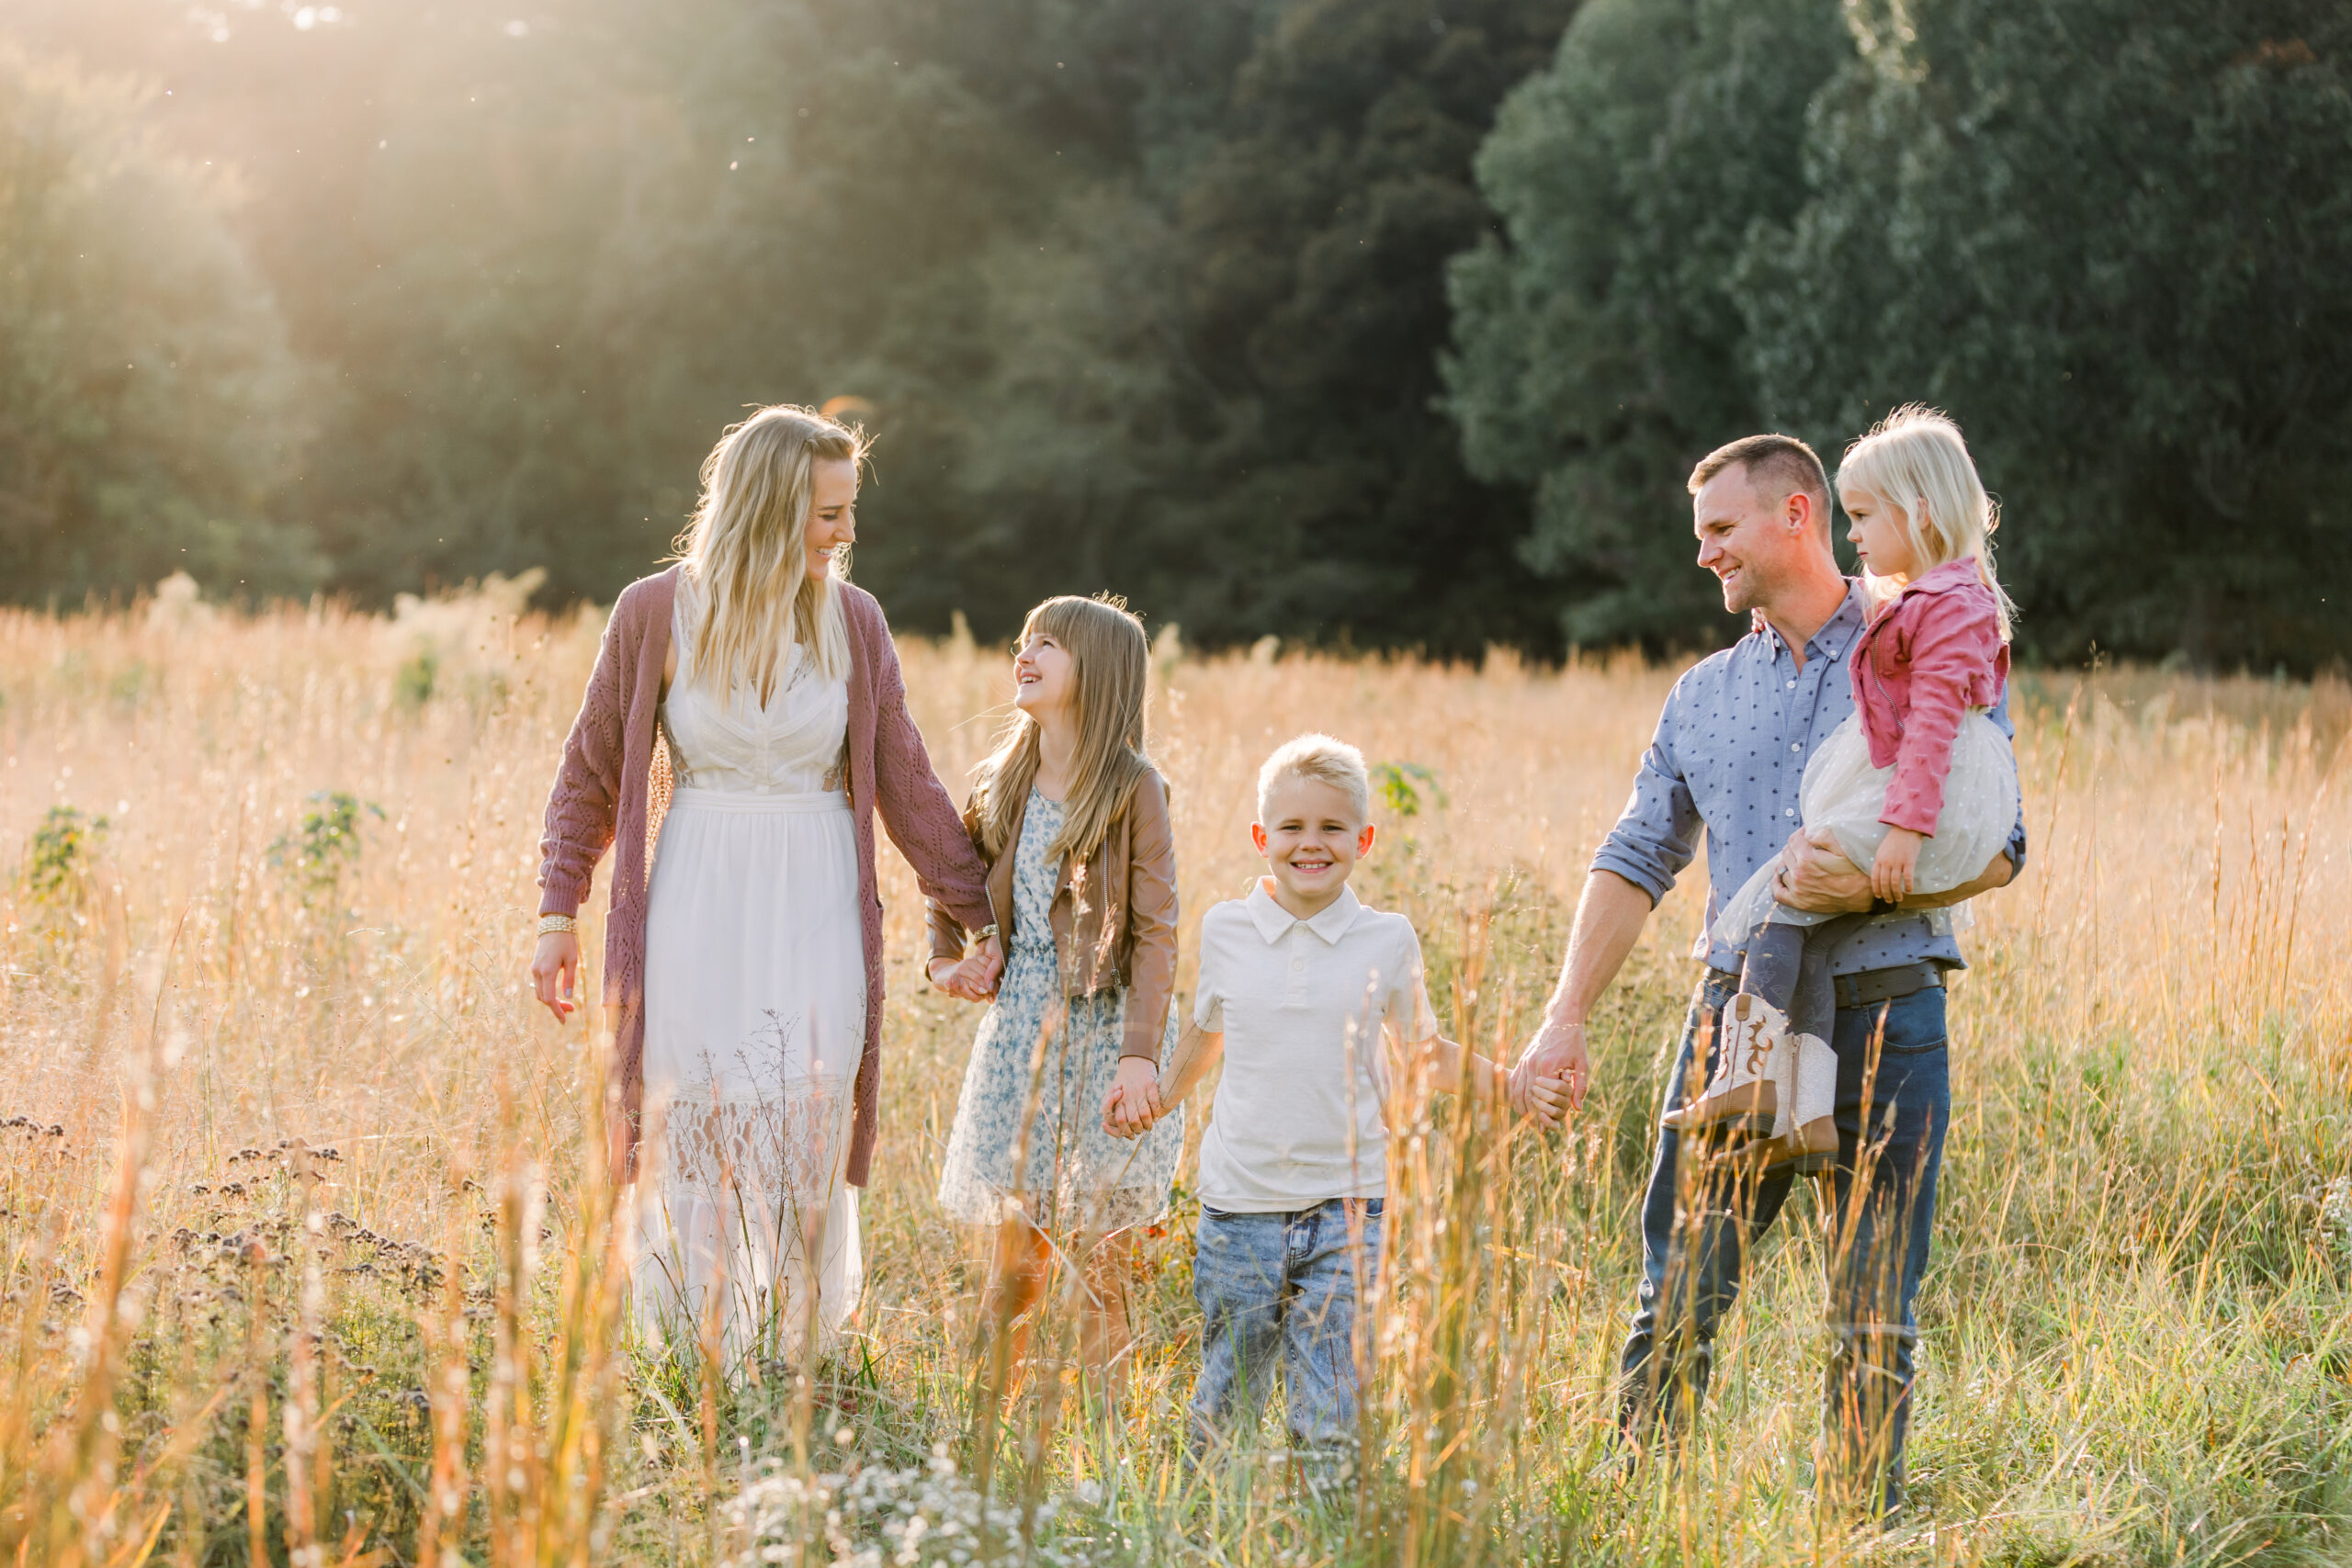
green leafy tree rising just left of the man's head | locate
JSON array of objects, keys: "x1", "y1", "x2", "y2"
[{"x1": 1444, "y1": 0, "x2": 1851, "y2": 647}]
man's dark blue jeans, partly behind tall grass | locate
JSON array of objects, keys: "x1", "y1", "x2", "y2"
[{"x1": 1618, "y1": 971, "x2": 1952, "y2": 1506}]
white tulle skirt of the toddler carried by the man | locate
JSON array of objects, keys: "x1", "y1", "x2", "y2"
[{"x1": 1714, "y1": 707, "x2": 2018, "y2": 947}]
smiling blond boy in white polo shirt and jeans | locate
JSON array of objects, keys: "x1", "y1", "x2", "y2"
[{"x1": 1103, "y1": 736, "x2": 1562, "y2": 1464}]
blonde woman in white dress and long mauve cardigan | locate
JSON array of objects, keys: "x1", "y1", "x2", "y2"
[{"x1": 534, "y1": 407, "x2": 1000, "y2": 1366}]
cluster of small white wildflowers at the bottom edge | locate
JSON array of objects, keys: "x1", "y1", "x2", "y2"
[{"x1": 724, "y1": 1446, "x2": 1114, "y2": 1568}]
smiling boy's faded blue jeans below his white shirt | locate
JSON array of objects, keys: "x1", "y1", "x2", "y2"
[{"x1": 1193, "y1": 1199, "x2": 1383, "y2": 1458}]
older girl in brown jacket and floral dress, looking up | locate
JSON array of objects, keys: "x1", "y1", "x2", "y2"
[{"x1": 929, "y1": 597, "x2": 1183, "y2": 1408}]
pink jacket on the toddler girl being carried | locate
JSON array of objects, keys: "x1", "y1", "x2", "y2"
[{"x1": 1847, "y1": 558, "x2": 2008, "y2": 837}]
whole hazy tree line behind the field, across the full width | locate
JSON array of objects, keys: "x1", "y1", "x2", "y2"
[{"x1": 0, "y1": 0, "x2": 2352, "y2": 670}]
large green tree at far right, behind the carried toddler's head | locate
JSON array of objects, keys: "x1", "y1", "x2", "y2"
[{"x1": 1740, "y1": 0, "x2": 2352, "y2": 670}]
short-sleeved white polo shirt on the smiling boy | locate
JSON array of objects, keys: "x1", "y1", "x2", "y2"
[{"x1": 1193, "y1": 877, "x2": 1437, "y2": 1213}]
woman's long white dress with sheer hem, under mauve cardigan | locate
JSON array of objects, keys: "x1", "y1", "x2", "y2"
[{"x1": 633, "y1": 588, "x2": 865, "y2": 1361}]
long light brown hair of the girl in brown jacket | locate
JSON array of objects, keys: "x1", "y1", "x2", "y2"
[{"x1": 971, "y1": 594, "x2": 1152, "y2": 865}]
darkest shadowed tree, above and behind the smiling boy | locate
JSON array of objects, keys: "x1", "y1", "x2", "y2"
[{"x1": 1105, "y1": 0, "x2": 1574, "y2": 653}]
